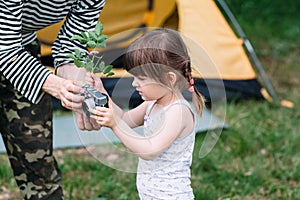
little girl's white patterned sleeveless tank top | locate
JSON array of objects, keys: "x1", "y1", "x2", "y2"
[{"x1": 137, "y1": 99, "x2": 196, "y2": 200}]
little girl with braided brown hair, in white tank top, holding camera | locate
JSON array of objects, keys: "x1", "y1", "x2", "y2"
[{"x1": 90, "y1": 28, "x2": 204, "y2": 200}]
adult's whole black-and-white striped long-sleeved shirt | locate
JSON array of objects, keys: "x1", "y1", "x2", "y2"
[{"x1": 0, "y1": 0, "x2": 105, "y2": 103}]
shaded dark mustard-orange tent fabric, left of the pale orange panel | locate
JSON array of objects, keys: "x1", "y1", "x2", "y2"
[{"x1": 37, "y1": 0, "x2": 176, "y2": 57}]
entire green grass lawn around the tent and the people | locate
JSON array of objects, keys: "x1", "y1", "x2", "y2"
[{"x1": 0, "y1": 0, "x2": 300, "y2": 200}]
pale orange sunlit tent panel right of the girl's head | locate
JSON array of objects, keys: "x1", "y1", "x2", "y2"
[{"x1": 176, "y1": 0, "x2": 255, "y2": 80}]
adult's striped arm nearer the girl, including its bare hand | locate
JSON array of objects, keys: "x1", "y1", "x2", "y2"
[{"x1": 52, "y1": 0, "x2": 105, "y2": 130}]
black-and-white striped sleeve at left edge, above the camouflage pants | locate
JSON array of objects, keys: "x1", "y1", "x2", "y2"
[{"x1": 0, "y1": 0, "x2": 51, "y2": 103}]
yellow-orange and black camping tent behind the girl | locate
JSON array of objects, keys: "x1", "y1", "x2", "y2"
[{"x1": 37, "y1": 0, "x2": 263, "y2": 101}]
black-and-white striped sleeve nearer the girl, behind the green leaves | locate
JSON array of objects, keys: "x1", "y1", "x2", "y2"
[{"x1": 52, "y1": 0, "x2": 105, "y2": 67}]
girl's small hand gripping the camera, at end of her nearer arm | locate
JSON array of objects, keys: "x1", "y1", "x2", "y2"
[{"x1": 90, "y1": 106, "x2": 117, "y2": 128}]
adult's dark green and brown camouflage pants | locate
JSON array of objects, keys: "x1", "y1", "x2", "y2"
[{"x1": 0, "y1": 39, "x2": 63, "y2": 200}]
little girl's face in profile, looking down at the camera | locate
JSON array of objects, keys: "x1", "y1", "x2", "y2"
[{"x1": 132, "y1": 76, "x2": 170, "y2": 101}]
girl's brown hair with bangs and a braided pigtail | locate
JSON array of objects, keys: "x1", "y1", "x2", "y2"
[{"x1": 123, "y1": 28, "x2": 204, "y2": 116}]
